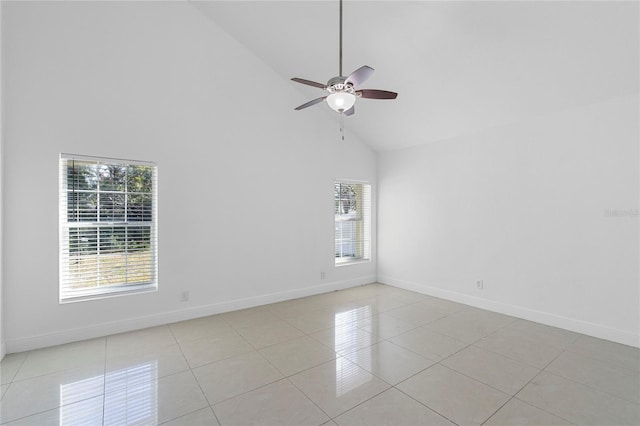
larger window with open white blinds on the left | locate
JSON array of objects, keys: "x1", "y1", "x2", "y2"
[{"x1": 59, "y1": 154, "x2": 158, "y2": 302}]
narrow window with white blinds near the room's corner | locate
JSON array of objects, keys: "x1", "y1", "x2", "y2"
[{"x1": 334, "y1": 182, "x2": 371, "y2": 265}]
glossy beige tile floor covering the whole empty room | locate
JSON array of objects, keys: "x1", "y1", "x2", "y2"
[{"x1": 0, "y1": 284, "x2": 640, "y2": 426}]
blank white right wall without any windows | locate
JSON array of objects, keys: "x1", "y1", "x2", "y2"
[{"x1": 378, "y1": 94, "x2": 640, "y2": 346}]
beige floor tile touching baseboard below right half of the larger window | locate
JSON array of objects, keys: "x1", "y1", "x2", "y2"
[{"x1": 107, "y1": 325, "x2": 177, "y2": 358}]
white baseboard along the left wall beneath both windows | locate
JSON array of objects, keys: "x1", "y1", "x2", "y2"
[{"x1": 5, "y1": 275, "x2": 376, "y2": 353}]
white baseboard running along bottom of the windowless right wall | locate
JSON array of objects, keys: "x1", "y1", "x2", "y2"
[{"x1": 378, "y1": 276, "x2": 640, "y2": 348}]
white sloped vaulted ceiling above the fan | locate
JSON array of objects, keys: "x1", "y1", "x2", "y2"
[{"x1": 192, "y1": 0, "x2": 639, "y2": 150}]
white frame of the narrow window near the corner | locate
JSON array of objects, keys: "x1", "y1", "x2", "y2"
[{"x1": 333, "y1": 179, "x2": 373, "y2": 267}]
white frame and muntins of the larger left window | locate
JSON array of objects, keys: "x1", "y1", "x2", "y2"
[{"x1": 58, "y1": 153, "x2": 158, "y2": 304}]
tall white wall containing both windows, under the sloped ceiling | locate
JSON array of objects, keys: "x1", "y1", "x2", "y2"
[{"x1": 2, "y1": 2, "x2": 376, "y2": 352}]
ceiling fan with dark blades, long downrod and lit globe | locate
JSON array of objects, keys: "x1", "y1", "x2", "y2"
[{"x1": 291, "y1": 0, "x2": 398, "y2": 116}]
